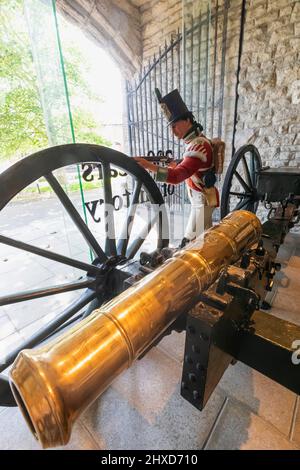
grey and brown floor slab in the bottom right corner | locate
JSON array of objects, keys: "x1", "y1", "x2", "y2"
[{"x1": 205, "y1": 399, "x2": 299, "y2": 450}]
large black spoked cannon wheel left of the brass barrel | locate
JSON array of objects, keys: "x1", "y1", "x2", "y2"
[{"x1": 0, "y1": 144, "x2": 169, "y2": 406}]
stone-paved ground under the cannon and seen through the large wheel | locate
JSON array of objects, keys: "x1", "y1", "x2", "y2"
[{"x1": 0, "y1": 196, "x2": 300, "y2": 450}]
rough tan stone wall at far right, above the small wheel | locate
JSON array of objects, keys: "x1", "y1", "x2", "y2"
[{"x1": 237, "y1": 0, "x2": 300, "y2": 166}]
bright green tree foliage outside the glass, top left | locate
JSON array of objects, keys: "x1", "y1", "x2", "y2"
[{"x1": 0, "y1": 0, "x2": 110, "y2": 160}]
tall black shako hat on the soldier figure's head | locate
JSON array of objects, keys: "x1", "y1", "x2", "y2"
[{"x1": 155, "y1": 88, "x2": 193, "y2": 126}]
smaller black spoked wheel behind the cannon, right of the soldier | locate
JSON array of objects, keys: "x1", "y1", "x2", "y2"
[{"x1": 221, "y1": 144, "x2": 262, "y2": 218}]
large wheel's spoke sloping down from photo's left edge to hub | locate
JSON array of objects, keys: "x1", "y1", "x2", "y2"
[{"x1": 0, "y1": 235, "x2": 101, "y2": 275}]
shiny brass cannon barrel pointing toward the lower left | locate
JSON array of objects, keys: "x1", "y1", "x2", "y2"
[{"x1": 10, "y1": 211, "x2": 261, "y2": 448}]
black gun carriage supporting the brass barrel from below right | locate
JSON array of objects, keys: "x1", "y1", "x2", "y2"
[{"x1": 181, "y1": 204, "x2": 300, "y2": 410}]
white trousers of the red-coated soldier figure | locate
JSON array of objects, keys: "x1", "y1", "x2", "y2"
[{"x1": 184, "y1": 187, "x2": 215, "y2": 240}]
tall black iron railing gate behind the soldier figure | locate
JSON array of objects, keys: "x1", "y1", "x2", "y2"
[{"x1": 126, "y1": 0, "x2": 230, "y2": 210}]
